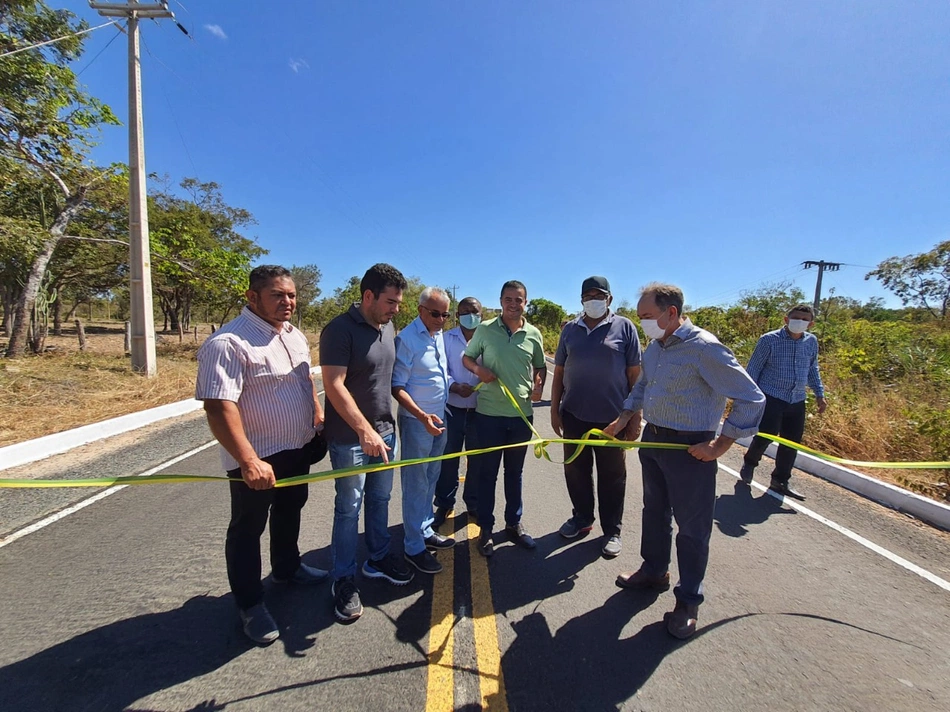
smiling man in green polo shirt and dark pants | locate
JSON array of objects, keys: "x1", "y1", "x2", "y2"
[{"x1": 462, "y1": 280, "x2": 548, "y2": 556}]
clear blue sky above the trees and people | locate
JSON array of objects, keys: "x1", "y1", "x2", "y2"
[{"x1": 70, "y1": 0, "x2": 950, "y2": 310}]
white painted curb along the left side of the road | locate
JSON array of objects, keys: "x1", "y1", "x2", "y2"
[{"x1": 0, "y1": 366, "x2": 320, "y2": 471}]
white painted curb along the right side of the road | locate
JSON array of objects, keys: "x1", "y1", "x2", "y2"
[{"x1": 737, "y1": 438, "x2": 950, "y2": 531}]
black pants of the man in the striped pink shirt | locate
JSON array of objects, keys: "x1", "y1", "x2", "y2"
[{"x1": 224, "y1": 449, "x2": 310, "y2": 610}]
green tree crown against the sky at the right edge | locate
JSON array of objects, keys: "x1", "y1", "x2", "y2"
[{"x1": 864, "y1": 240, "x2": 950, "y2": 319}]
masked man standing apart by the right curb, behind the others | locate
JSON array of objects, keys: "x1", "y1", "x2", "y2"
[{"x1": 739, "y1": 304, "x2": 827, "y2": 500}]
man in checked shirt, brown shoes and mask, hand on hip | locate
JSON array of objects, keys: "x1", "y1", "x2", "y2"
[{"x1": 604, "y1": 282, "x2": 765, "y2": 639}]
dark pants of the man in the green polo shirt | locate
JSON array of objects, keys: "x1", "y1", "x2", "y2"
[{"x1": 473, "y1": 413, "x2": 531, "y2": 533}]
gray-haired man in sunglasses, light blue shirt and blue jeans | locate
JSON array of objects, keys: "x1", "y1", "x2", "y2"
[{"x1": 392, "y1": 287, "x2": 455, "y2": 574}]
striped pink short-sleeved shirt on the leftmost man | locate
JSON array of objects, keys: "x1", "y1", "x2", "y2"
[{"x1": 195, "y1": 307, "x2": 315, "y2": 470}]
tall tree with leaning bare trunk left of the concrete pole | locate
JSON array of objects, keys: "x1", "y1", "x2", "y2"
[{"x1": 0, "y1": 0, "x2": 119, "y2": 357}]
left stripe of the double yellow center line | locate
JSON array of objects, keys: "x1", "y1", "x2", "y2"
[{"x1": 426, "y1": 517, "x2": 455, "y2": 712}]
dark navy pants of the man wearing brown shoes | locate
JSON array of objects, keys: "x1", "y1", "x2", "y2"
[{"x1": 640, "y1": 424, "x2": 719, "y2": 605}]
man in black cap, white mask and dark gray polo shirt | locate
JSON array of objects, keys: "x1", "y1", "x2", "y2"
[{"x1": 551, "y1": 277, "x2": 640, "y2": 558}]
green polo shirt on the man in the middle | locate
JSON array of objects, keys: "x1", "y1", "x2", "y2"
[{"x1": 465, "y1": 316, "x2": 544, "y2": 418}]
